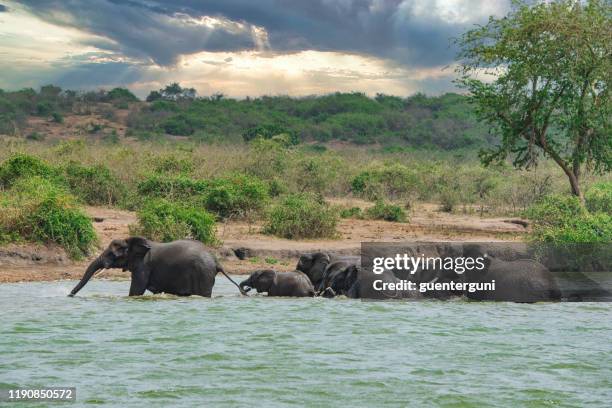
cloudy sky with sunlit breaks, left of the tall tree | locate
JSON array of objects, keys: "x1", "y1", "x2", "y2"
[{"x1": 0, "y1": 0, "x2": 510, "y2": 98}]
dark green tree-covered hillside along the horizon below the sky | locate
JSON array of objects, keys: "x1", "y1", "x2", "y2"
[{"x1": 0, "y1": 84, "x2": 494, "y2": 150}]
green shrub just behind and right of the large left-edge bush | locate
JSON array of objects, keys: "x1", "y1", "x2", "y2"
[{"x1": 64, "y1": 162, "x2": 125, "y2": 205}]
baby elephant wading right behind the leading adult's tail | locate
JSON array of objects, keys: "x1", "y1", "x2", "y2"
[{"x1": 240, "y1": 269, "x2": 314, "y2": 297}]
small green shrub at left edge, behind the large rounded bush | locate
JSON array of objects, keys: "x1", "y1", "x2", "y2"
[{"x1": 0, "y1": 153, "x2": 62, "y2": 188}]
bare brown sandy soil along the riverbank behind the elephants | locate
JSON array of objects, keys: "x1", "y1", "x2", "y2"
[{"x1": 0, "y1": 199, "x2": 526, "y2": 282}]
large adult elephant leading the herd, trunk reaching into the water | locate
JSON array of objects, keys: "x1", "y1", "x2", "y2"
[{"x1": 69, "y1": 237, "x2": 242, "y2": 297}]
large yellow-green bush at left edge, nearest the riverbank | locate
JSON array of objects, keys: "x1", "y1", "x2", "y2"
[{"x1": 0, "y1": 177, "x2": 97, "y2": 259}]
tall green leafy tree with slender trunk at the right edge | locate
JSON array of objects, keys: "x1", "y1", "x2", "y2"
[{"x1": 457, "y1": 0, "x2": 612, "y2": 201}]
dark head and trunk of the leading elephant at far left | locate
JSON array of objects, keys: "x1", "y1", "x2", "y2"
[{"x1": 69, "y1": 237, "x2": 151, "y2": 296}]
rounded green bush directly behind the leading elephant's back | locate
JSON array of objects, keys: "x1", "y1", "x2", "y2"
[{"x1": 130, "y1": 199, "x2": 217, "y2": 245}]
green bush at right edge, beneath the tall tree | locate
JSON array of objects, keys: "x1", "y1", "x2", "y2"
[{"x1": 526, "y1": 195, "x2": 612, "y2": 243}]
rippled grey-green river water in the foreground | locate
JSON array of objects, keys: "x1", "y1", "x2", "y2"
[{"x1": 0, "y1": 276, "x2": 612, "y2": 407}]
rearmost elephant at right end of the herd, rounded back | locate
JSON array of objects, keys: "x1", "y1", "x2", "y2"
[{"x1": 461, "y1": 245, "x2": 561, "y2": 303}]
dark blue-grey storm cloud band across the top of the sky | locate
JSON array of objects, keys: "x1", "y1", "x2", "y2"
[{"x1": 16, "y1": 0, "x2": 504, "y2": 67}]
